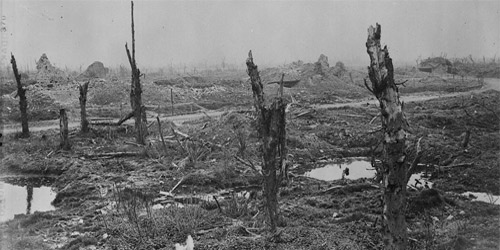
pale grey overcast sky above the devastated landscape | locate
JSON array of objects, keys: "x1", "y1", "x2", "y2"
[{"x1": 0, "y1": 0, "x2": 500, "y2": 68}]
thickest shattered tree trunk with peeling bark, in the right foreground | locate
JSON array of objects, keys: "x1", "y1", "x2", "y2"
[{"x1": 365, "y1": 24, "x2": 408, "y2": 249}]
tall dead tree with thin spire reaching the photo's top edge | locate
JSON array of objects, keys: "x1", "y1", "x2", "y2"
[{"x1": 125, "y1": 1, "x2": 147, "y2": 144}]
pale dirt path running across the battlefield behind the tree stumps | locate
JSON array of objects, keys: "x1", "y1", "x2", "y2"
[{"x1": 3, "y1": 78, "x2": 500, "y2": 135}]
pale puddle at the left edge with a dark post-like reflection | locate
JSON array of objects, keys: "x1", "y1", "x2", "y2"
[{"x1": 0, "y1": 180, "x2": 56, "y2": 222}]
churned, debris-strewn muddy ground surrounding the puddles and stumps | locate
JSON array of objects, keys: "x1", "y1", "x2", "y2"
[{"x1": 0, "y1": 67, "x2": 500, "y2": 249}]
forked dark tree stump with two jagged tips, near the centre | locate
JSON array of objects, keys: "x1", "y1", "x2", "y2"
[{"x1": 246, "y1": 51, "x2": 286, "y2": 232}]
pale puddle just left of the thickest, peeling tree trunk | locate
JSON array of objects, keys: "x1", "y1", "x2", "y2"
[{"x1": 304, "y1": 158, "x2": 375, "y2": 181}]
